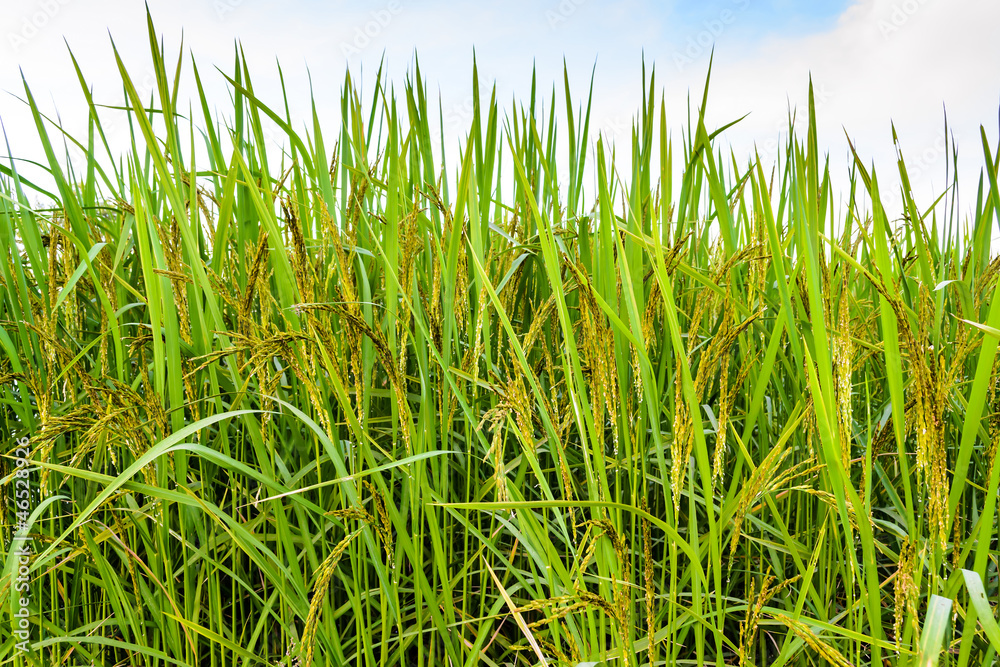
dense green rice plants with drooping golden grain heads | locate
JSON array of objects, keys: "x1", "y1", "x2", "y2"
[{"x1": 0, "y1": 15, "x2": 1000, "y2": 667}]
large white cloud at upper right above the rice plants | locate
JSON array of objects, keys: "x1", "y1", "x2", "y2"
[{"x1": 684, "y1": 0, "x2": 1000, "y2": 217}]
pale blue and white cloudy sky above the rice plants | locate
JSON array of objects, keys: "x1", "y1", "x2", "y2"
[{"x1": 0, "y1": 0, "x2": 1000, "y2": 224}]
